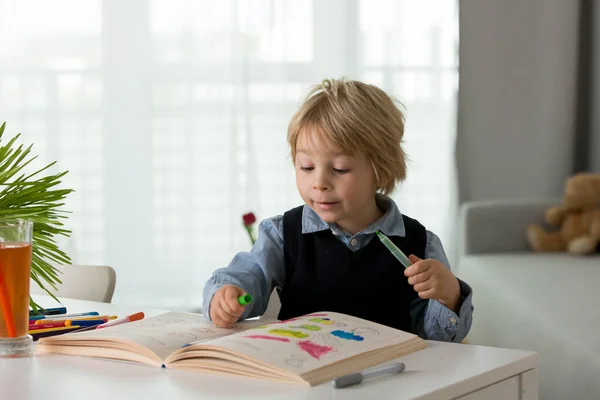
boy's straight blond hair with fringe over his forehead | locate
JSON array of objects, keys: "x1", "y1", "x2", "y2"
[{"x1": 288, "y1": 79, "x2": 406, "y2": 194}]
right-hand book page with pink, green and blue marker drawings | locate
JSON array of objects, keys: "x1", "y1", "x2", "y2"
[{"x1": 186, "y1": 312, "x2": 421, "y2": 374}]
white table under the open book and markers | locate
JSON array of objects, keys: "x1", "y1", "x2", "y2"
[{"x1": 0, "y1": 296, "x2": 538, "y2": 400}]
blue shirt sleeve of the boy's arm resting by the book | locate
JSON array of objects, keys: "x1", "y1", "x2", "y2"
[{"x1": 202, "y1": 216, "x2": 285, "y2": 319}]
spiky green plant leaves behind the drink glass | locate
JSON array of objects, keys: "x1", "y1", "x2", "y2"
[{"x1": 0, "y1": 122, "x2": 73, "y2": 310}]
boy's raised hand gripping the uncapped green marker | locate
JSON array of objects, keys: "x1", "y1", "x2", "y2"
[{"x1": 404, "y1": 254, "x2": 460, "y2": 313}]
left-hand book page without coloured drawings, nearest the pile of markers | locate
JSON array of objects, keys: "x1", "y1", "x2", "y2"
[{"x1": 40, "y1": 312, "x2": 265, "y2": 360}]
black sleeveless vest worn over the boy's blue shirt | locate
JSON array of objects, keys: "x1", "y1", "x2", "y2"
[{"x1": 278, "y1": 206, "x2": 427, "y2": 334}]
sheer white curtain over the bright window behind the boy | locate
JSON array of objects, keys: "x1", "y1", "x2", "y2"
[{"x1": 0, "y1": 0, "x2": 458, "y2": 309}]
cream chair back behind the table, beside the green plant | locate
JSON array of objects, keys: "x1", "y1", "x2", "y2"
[{"x1": 30, "y1": 265, "x2": 117, "y2": 303}]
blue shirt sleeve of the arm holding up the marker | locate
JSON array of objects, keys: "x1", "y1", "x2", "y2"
[{"x1": 411, "y1": 231, "x2": 473, "y2": 342}]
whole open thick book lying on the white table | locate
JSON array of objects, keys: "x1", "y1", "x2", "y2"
[{"x1": 37, "y1": 312, "x2": 427, "y2": 386}]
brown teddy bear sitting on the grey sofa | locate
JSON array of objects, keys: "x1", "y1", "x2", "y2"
[{"x1": 527, "y1": 172, "x2": 600, "y2": 255}]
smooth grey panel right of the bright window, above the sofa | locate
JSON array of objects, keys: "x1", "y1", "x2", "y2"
[{"x1": 456, "y1": 0, "x2": 578, "y2": 202}]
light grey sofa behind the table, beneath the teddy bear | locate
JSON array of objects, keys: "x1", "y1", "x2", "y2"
[{"x1": 455, "y1": 200, "x2": 600, "y2": 400}]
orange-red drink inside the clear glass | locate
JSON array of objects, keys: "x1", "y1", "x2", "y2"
[{"x1": 0, "y1": 242, "x2": 31, "y2": 339}]
